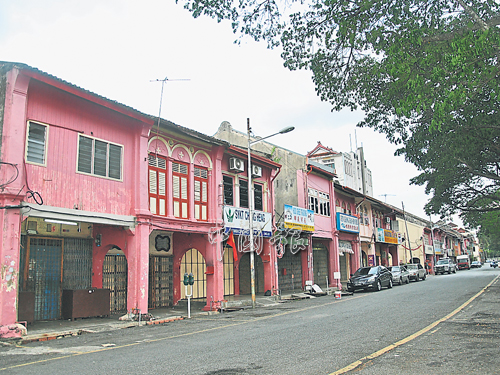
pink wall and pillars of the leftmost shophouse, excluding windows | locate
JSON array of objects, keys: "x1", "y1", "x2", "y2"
[{"x1": 0, "y1": 69, "x2": 151, "y2": 332}]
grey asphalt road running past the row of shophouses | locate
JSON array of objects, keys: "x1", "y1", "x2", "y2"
[{"x1": 0, "y1": 267, "x2": 500, "y2": 375}]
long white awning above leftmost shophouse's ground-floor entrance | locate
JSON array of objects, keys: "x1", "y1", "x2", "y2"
[{"x1": 21, "y1": 202, "x2": 136, "y2": 228}]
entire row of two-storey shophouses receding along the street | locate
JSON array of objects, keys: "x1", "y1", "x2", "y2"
[{"x1": 0, "y1": 62, "x2": 477, "y2": 338}]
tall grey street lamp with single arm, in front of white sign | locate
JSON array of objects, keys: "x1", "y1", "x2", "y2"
[{"x1": 247, "y1": 118, "x2": 295, "y2": 308}]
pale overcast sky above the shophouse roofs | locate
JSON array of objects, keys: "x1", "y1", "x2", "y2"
[{"x1": 0, "y1": 0, "x2": 454, "y2": 226}]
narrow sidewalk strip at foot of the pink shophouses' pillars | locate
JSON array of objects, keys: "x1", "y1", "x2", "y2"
[{"x1": 4, "y1": 292, "x2": 310, "y2": 344}]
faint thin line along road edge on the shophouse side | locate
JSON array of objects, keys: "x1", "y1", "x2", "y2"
[{"x1": 0, "y1": 295, "x2": 366, "y2": 371}]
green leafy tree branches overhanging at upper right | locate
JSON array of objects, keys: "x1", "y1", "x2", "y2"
[{"x1": 178, "y1": 0, "x2": 500, "y2": 229}]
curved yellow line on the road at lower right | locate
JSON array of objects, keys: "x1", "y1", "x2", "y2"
[{"x1": 329, "y1": 275, "x2": 500, "y2": 375}]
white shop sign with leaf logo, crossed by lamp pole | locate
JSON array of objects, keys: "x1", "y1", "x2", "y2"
[{"x1": 224, "y1": 206, "x2": 273, "y2": 237}]
